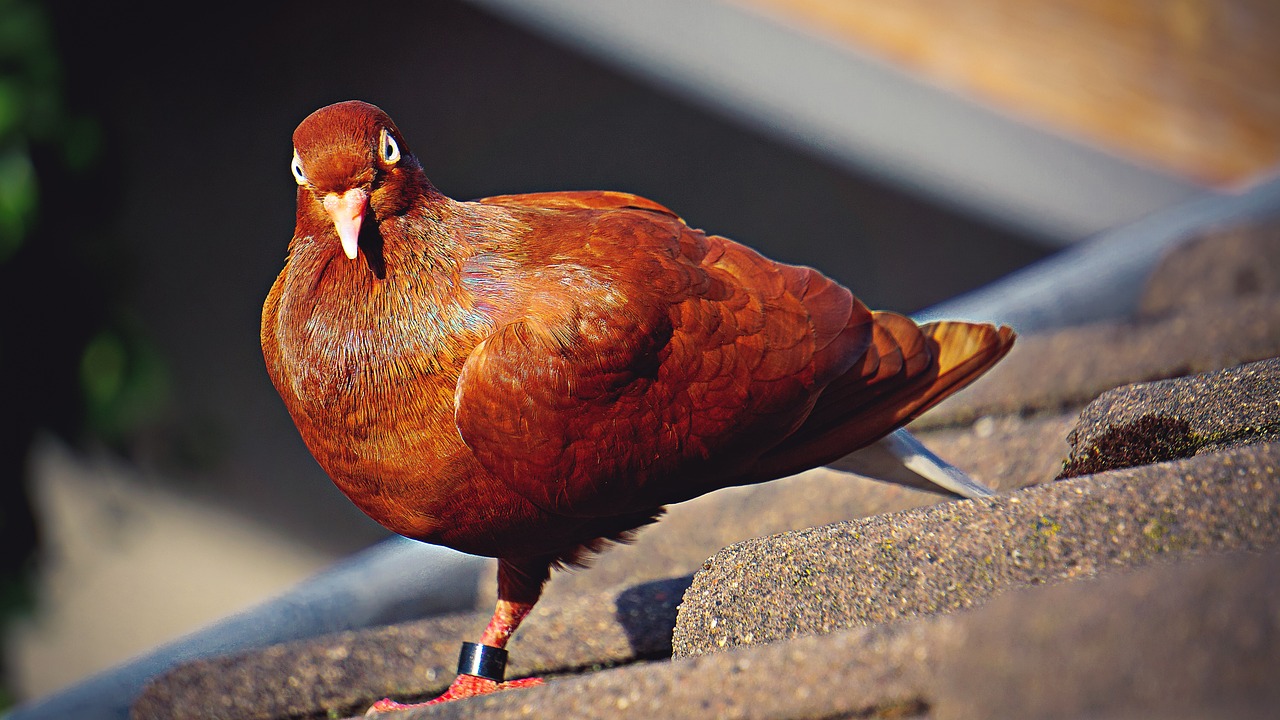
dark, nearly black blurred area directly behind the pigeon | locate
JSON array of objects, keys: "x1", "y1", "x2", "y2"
[{"x1": 0, "y1": 0, "x2": 1046, "y2": 599}]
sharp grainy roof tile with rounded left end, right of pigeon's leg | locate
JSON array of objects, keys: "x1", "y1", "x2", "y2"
[{"x1": 672, "y1": 445, "x2": 1280, "y2": 656}]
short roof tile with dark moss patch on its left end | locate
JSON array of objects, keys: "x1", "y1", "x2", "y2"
[{"x1": 1062, "y1": 357, "x2": 1280, "y2": 478}]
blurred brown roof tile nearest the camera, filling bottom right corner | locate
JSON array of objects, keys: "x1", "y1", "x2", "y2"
[{"x1": 386, "y1": 543, "x2": 1280, "y2": 720}]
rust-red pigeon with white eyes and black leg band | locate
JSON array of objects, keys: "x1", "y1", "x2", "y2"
[{"x1": 262, "y1": 101, "x2": 1014, "y2": 712}]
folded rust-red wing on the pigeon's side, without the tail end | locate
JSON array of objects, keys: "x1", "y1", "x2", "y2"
[{"x1": 456, "y1": 193, "x2": 872, "y2": 516}]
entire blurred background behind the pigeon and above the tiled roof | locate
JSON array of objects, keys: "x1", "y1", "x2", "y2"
[{"x1": 0, "y1": 0, "x2": 1280, "y2": 708}]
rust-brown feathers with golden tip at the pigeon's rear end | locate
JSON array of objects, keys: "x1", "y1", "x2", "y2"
[{"x1": 759, "y1": 313, "x2": 1015, "y2": 479}]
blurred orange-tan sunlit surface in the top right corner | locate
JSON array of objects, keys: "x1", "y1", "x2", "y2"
[{"x1": 728, "y1": 0, "x2": 1280, "y2": 187}]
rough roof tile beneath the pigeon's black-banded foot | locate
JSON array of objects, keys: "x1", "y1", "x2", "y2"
[{"x1": 132, "y1": 578, "x2": 689, "y2": 720}]
